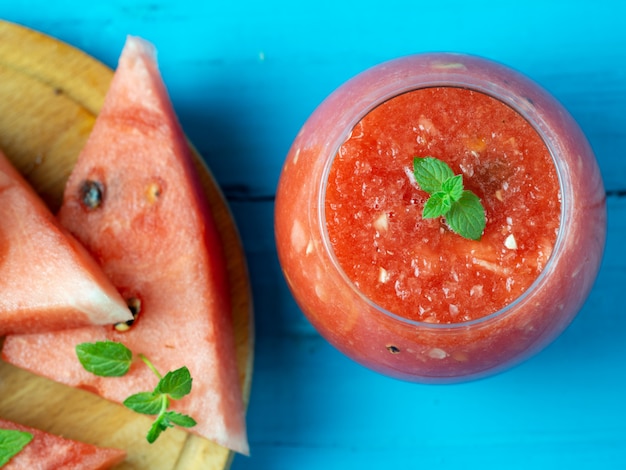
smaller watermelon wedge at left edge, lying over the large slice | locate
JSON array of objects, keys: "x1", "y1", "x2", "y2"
[{"x1": 0, "y1": 152, "x2": 132, "y2": 336}]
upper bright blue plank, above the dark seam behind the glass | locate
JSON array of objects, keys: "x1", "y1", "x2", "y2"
[{"x1": 3, "y1": 0, "x2": 626, "y2": 195}]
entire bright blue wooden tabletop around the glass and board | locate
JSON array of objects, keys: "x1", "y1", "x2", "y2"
[{"x1": 0, "y1": 0, "x2": 626, "y2": 470}]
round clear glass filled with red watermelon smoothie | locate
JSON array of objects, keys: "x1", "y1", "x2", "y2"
[{"x1": 275, "y1": 53, "x2": 606, "y2": 383}]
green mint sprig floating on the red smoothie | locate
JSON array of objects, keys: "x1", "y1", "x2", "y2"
[{"x1": 413, "y1": 157, "x2": 487, "y2": 240}]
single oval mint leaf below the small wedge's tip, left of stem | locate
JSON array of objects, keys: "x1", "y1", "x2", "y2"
[{"x1": 76, "y1": 341, "x2": 133, "y2": 377}]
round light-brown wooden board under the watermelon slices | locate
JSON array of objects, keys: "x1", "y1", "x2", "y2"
[{"x1": 0, "y1": 21, "x2": 253, "y2": 470}]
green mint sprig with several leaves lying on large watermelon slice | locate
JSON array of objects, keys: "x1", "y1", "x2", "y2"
[{"x1": 76, "y1": 341, "x2": 196, "y2": 444}]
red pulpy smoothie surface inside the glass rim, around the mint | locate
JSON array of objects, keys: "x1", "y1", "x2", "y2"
[{"x1": 325, "y1": 87, "x2": 561, "y2": 323}]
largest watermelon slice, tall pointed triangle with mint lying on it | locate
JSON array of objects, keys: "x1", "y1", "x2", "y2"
[{"x1": 3, "y1": 37, "x2": 249, "y2": 454}]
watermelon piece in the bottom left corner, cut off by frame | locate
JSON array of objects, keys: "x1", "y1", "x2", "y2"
[{"x1": 0, "y1": 419, "x2": 126, "y2": 470}]
